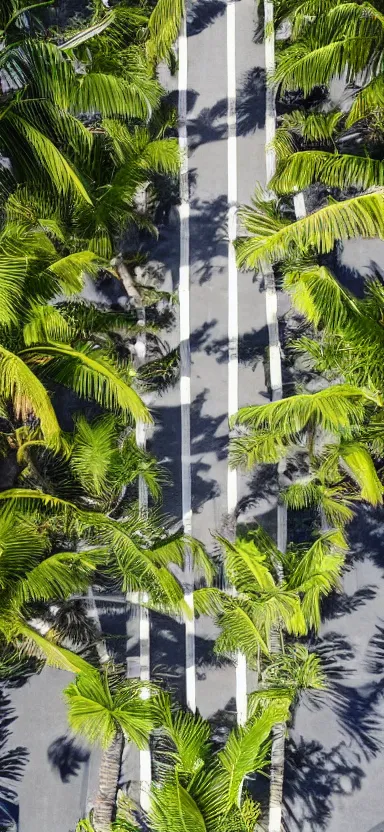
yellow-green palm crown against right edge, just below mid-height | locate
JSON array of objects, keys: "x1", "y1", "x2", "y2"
[{"x1": 231, "y1": 380, "x2": 383, "y2": 527}]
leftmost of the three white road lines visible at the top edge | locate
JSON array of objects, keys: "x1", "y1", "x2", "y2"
[{"x1": 179, "y1": 15, "x2": 196, "y2": 711}]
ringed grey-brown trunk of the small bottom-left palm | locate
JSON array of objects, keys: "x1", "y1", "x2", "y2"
[{"x1": 92, "y1": 731, "x2": 123, "y2": 832}]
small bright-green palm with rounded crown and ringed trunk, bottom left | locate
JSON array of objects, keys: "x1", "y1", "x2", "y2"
[{"x1": 64, "y1": 671, "x2": 159, "y2": 832}]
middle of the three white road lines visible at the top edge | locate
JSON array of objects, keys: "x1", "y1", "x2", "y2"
[{"x1": 226, "y1": 0, "x2": 247, "y2": 725}]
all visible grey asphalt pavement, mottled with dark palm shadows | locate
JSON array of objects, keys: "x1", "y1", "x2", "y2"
[{"x1": 0, "y1": 0, "x2": 384, "y2": 832}]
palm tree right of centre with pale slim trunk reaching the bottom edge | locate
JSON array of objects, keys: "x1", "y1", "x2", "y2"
[{"x1": 194, "y1": 528, "x2": 345, "y2": 832}]
